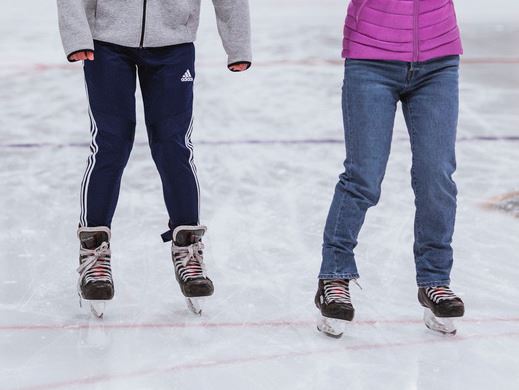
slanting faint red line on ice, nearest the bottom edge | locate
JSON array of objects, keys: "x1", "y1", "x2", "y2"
[{"x1": 9, "y1": 332, "x2": 519, "y2": 390}]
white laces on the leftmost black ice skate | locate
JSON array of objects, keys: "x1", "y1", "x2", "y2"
[{"x1": 77, "y1": 242, "x2": 112, "y2": 291}]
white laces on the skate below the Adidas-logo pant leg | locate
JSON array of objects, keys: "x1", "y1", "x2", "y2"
[{"x1": 172, "y1": 241, "x2": 206, "y2": 281}]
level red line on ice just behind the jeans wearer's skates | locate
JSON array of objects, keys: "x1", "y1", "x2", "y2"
[{"x1": 0, "y1": 317, "x2": 519, "y2": 331}]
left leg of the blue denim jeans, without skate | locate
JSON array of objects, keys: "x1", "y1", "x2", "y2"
[{"x1": 319, "y1": 60, "x2": 402, "y2": 279}]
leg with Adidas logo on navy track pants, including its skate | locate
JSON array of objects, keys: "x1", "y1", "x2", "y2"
[{"x1": 139, "y1": 49, "x2": 214, "y2": 315}]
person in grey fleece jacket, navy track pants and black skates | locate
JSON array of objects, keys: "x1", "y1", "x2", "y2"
[{"x1": 57, "y1": 0, "x2": 252, "y2": 317}]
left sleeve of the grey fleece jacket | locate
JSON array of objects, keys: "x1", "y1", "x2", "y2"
[{"x1": 57, "y1": 0, "x2": 94, "y2": 61}]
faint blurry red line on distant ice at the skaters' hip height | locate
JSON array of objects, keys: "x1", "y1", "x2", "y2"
[{"x1": 0, "y1": 56, "x2": 519, "y2": 77}]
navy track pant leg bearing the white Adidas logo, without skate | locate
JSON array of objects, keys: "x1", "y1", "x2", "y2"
[{"x1": 139, "y1": 44, "x2": 199, "y2": 229}]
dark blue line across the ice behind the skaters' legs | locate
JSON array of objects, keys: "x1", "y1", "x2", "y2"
[{"x1": 0, "y1": 135, "x2": 519, "y2": 149}]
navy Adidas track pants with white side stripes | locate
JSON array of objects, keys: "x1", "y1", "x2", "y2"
[{"x1": 80, "y1": 41, "x2": 199, "y2": 238}]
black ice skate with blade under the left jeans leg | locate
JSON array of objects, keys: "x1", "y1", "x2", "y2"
[{"x1": 315, "y1": 279, "x2": 355, "y2": 338}]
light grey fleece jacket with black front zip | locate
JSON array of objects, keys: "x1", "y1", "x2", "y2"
[{"x1": 57, "y1": 0, "x2": 252, "y2": 64}]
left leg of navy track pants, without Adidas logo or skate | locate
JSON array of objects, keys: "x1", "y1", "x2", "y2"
[{"x1": 80, "y1": 42, "x2": 136, "y2": 227}]
